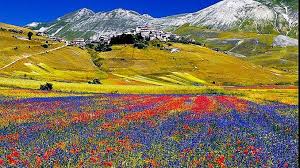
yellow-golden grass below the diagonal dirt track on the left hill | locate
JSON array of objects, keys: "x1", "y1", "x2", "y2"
[{"x1": 0, "y1": 47, "x2": 106, "y2": 82}]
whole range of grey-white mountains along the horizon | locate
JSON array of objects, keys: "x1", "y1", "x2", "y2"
[{"x1": 26, "y1": 0, "x2": 298, "y2": 39}]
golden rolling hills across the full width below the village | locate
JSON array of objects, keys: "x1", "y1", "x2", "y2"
[{"x1": 0, "y1": 24, "x2": 297, "y2": 87}]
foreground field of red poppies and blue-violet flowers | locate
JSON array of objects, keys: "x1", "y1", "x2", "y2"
[{"x1": 0, "y1": 94, "x2": 299, "y2": 168}]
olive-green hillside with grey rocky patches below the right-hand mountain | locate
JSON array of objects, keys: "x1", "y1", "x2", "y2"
[{"x1": 174, "y1": 24, "x2": 299, "y2": 75}]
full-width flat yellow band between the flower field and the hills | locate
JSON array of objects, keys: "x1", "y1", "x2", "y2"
[{"x1": 0, "y1": 77, "x2": 298, "y2": 105}]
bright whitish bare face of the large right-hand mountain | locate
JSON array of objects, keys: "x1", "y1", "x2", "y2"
[{"x1": 155, "y1": 0, "x2": 275, "y2": 29}]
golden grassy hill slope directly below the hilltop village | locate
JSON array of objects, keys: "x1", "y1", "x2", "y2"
[{"x1": 92, "y1": 43, "x2": 295, "y2": 85}]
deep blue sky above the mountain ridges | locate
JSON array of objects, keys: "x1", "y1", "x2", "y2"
[{"x1": 0, "y1": 0, "x2": 220, "y2": 25}]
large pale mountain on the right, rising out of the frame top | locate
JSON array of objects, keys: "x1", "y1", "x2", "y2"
[{"x1": 157, "y1": 0, "x2": 298, "y2": 35}]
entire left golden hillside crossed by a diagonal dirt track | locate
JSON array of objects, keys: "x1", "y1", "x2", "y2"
[{"x1": 0, "y1": 24, "x2": 105, "y2": 82}]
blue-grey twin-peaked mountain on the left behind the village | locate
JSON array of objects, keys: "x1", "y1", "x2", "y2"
[{"x1": 27, "y1": 8, "x2": 154, "y2": 39}]
